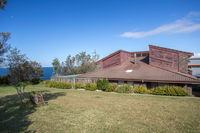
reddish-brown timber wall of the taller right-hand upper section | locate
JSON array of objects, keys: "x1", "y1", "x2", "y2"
[{"x1": 149, "y1": 45, "x2": 189, "y2": 73}]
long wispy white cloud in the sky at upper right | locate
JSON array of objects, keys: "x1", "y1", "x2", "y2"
[{"x1": 120, "y1": 12, "x2": 200, "y2": 38}]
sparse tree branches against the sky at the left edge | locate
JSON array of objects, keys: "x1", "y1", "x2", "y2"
[{"x1": 0, "y1": 32, "x2": 10, "y2": 65}]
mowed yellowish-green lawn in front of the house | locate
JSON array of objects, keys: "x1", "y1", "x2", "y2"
[{"x1": 0, "y1": 85, "x2": 200, "y2": 133}]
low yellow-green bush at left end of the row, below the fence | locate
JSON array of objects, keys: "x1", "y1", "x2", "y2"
[{"x1": 45, "y1": 81, "x2": 72, "y2": 89}]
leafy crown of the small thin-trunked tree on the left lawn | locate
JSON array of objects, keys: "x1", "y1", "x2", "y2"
[{"x1": 7, "y1": 48, "x2": 43, "y2": 84}]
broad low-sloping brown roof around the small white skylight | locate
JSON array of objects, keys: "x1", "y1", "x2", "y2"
[{"x1": 78, "y1": 57, "x2": 200, "y2": 84}]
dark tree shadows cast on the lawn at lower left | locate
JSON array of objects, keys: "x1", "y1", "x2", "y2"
[{"x1": 0, "y1": 92, "x2": 65, "y2": 133}]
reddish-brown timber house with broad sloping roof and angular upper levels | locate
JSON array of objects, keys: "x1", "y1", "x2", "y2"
[{"x1": 52, "y1": 45, "x2": 200, "y2": 94}]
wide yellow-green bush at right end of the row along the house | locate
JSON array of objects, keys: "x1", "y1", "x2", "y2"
[{"x1": 152, "y1": 86, "x2": 188, "y2": 96}]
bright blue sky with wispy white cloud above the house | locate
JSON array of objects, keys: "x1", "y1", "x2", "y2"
[{"x1": 0, "y1": 0, "x2": 200, "y2": 66}]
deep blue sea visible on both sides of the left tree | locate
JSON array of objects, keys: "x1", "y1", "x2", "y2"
[{"x1": 0, "y1": 67, "x2": 53, "y2": 80}]
